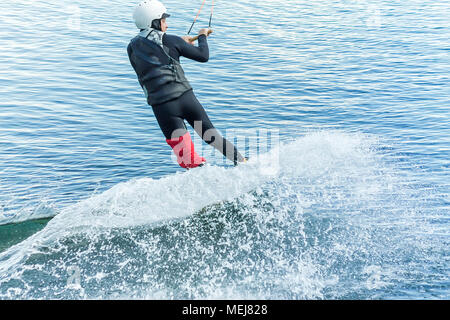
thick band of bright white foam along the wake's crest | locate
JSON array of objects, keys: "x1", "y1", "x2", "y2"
[{"x1": 0, "y1": 131, "x2": 382, "y2": 291}]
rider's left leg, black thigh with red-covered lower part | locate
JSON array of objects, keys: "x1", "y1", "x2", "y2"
[{"x1": 153, "y1": 99, "x2": 206, "y2": 169}]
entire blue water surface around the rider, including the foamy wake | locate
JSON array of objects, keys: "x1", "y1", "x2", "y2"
[{"x1": 0, "y1": 0, "x2": 450, "y2": 299}]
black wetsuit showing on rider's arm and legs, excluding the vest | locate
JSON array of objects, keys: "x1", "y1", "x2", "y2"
[{"x1": 137, "y1": 34, "x2": 244, "y2": 164}]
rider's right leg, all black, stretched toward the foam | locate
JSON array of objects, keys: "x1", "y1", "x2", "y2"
[{"x1": 178, "y1": 91, "x2": 245, "y2": 164}]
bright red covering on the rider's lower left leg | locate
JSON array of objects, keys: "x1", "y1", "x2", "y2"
[{"x1": 166, "y1": 132, "x2": 206, "y2": 169}]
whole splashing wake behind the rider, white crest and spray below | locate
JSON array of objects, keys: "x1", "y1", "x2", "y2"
[{"x1": 0, "y1": 131, "x2": 445, "y2": 299}]
